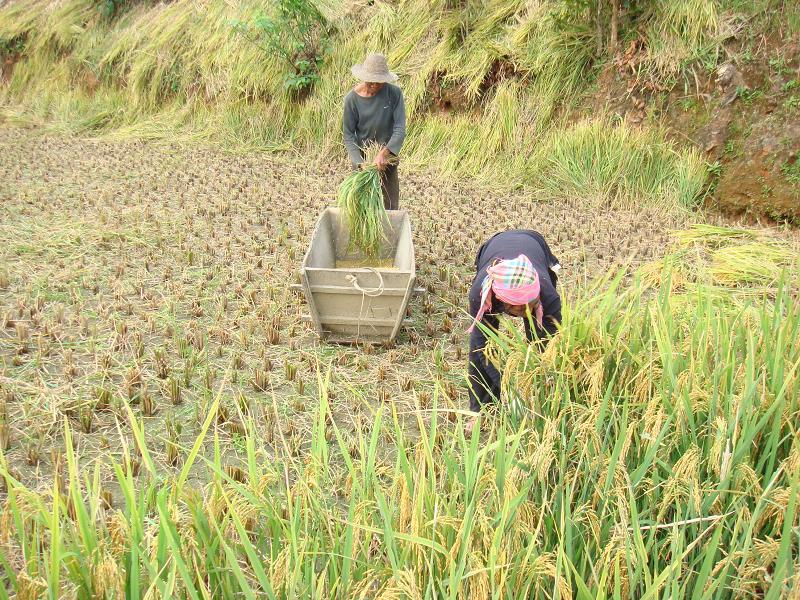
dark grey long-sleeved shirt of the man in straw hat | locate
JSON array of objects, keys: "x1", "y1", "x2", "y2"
[{"x1": 342, "y1": 83, "x2": 406, "y2": 165}]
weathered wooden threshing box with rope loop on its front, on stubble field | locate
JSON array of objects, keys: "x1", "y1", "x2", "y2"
[{"x1": 300, "y1": 208, "x2": 416, "y2": 342}]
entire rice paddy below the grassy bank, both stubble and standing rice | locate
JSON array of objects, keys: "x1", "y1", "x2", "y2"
[{"x1": 0, "y1": 128, "x2": 800, "y2": 598}]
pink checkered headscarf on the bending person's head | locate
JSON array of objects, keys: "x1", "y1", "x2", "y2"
[{"x1": 468, "y1": 254, "x2": 544, "y2": 333}]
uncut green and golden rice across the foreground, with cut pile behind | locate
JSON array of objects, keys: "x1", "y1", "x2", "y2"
[{"x1": 0, "y1": 227, "x2": 800, "y2": 600}]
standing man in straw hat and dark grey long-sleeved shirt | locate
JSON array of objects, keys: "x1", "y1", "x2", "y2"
[{"x1": 342, "y1": 54, "x2": 406, "y2": 210}]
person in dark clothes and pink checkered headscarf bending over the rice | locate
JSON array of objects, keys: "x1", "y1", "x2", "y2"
[{"x1": 467, "y1": 230, "x2": 561, "y2": 432}]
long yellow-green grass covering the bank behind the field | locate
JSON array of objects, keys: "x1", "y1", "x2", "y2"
[{"x1": 0, "y1": 0, "x2": 756, "y2": 206}]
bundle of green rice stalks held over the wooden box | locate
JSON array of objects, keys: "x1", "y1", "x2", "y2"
[{"x1": 339, "y1": 164, "x2": 388, "y2": 258}]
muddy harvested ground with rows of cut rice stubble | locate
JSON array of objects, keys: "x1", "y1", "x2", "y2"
[{"x1": 0, "y1": 128, "x2": 685, "y2": 488}]
